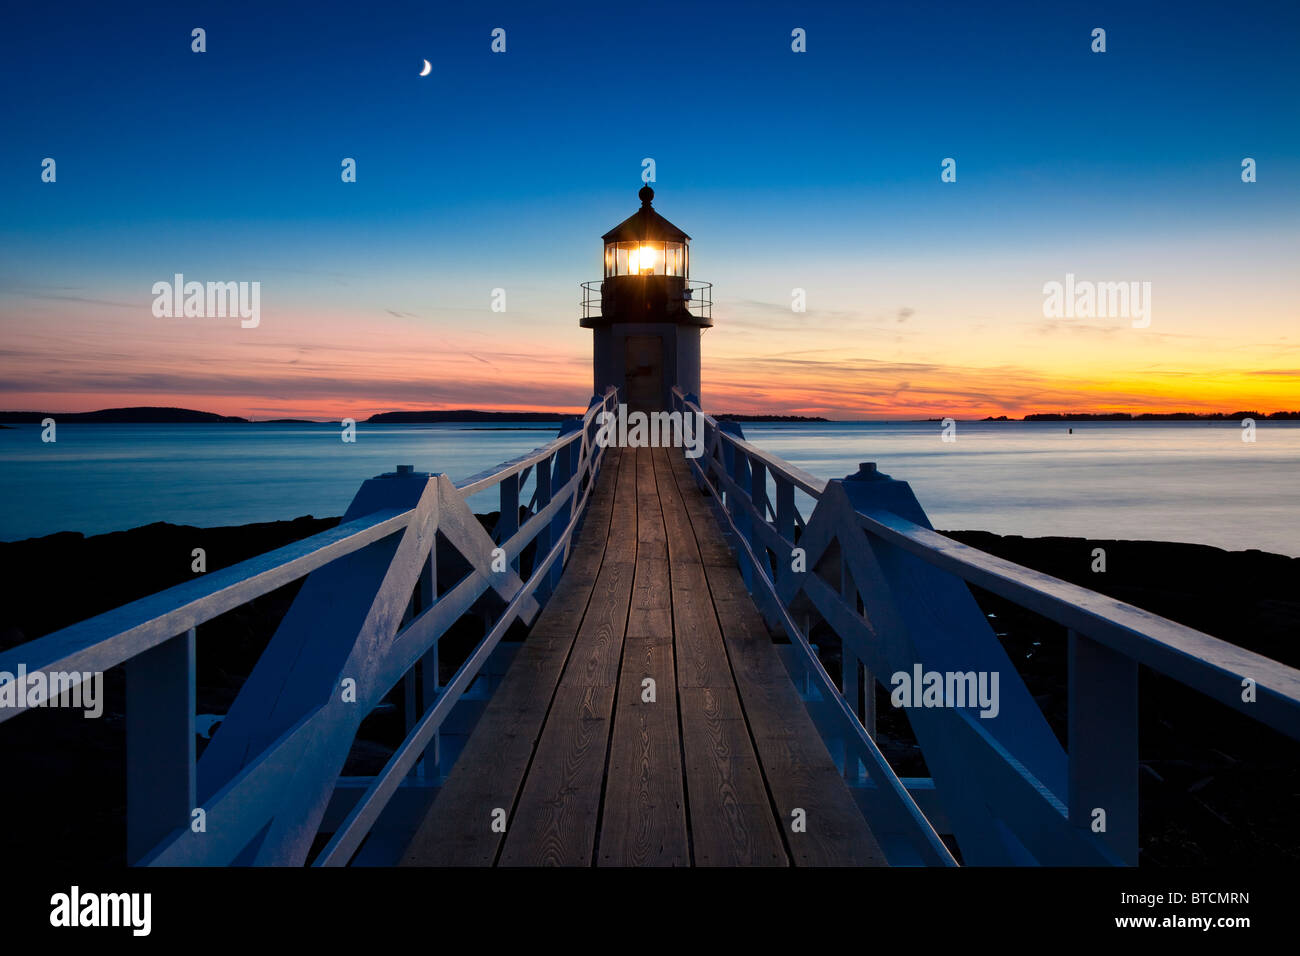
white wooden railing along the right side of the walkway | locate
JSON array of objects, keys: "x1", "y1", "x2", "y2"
[{"x1": 673, "y1": 389, "x2": 1300, "y2": 865}]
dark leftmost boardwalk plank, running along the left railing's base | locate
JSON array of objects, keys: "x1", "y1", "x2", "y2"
[{"x1": 402, "y1": 449, "x2": 621, "y2": 866}]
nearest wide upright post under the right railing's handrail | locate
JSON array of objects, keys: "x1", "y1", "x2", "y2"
[{"x1": 1069, "y1": 631, "x2": 1138, "y2": 866}]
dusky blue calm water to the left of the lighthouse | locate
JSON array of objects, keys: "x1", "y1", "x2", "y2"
[{"x1": 0, "y1": 423, "x2": 558, "y2": 541}]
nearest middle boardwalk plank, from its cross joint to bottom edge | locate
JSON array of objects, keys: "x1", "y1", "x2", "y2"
[{"x1": 597, "y1": 637, "x2": 690, "y2": 866}]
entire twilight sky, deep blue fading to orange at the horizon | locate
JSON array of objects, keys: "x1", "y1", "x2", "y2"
[{"x1": 0, "y1": 1, "x2": 1300, "y2": 419}]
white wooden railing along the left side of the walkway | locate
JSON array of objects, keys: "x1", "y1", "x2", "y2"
[{"x1": 0, "y1": 388, "x2": 618, "y2": 865}]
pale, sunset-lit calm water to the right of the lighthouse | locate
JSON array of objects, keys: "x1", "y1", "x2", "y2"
[{"x1": 742, "y1": 421, "x2": 1300, "y2": 557}]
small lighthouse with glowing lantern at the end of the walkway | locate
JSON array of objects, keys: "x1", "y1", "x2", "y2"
[{"x1": 580, "y1": 186, "x2": 714, "y2": 411}]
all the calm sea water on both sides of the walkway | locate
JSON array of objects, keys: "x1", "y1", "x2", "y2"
[{"x1": 0, "y1": 421, "x2": 1300, "y2": 557}]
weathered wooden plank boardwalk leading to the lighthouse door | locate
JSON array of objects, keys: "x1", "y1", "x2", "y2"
[{"x1": 403, "y1": 449, "x2": 884, "y2": 866}]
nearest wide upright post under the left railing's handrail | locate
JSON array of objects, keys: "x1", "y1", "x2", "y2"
[{"x1": 125, "y1": 627, "x2": 195, "y2": 864}]
